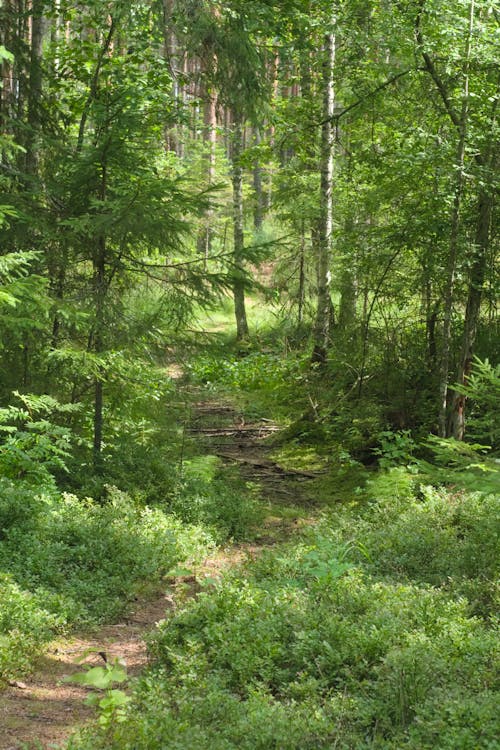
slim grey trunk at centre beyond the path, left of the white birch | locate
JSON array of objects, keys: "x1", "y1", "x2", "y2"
[{"x1": 231, "y1": 114, "x2": 248, "y2": 341}]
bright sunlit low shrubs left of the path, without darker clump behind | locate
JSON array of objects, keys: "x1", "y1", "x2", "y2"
[{"x1": 0, "y1": 478, "x2": 214, "y2": 680}]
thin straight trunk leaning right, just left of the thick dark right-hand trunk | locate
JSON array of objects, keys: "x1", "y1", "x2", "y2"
[{"x1": 439, "y1": 0, "x2": 474, "y2": 437}]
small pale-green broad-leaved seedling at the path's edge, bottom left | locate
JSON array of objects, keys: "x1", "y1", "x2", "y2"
[{"x1": 64, "y1": 652, "x2": 131, "y2": 730}]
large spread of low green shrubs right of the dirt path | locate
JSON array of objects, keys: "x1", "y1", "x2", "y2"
[{"x1": 70, "y1": 469, "x2": 500, "y2": 750}]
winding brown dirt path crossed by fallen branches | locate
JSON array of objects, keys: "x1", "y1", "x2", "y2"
[{"x1": 0, "y1": 400, "x2": 316, "y2": 750}]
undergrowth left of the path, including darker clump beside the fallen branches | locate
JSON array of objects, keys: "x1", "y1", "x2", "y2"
[{"x1": 0, "y1": 440, "x2": 265, "y2": 682}]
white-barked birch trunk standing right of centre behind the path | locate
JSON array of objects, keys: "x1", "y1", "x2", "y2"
[{"x1": 312, "y1": 19, "x2": 335, "y2": 364}]
